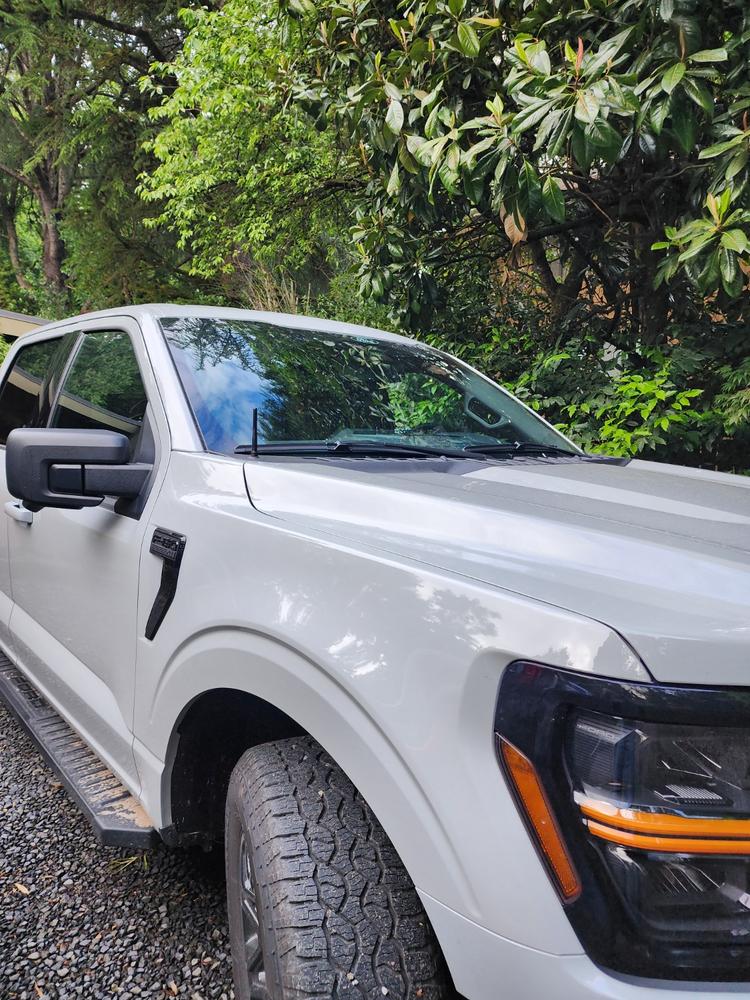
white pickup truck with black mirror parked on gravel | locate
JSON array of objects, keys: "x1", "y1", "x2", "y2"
[{"x1": 0, "y1": 305, "x2": 750, "y2": 1000}]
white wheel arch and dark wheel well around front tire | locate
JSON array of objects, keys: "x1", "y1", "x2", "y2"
[{"x1": 149, "y1": 628, "x2": 473, "y2": 916}]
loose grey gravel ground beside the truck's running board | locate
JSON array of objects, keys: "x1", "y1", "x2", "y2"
[{"x1": 0, "y1": 704, "x2": 234, "y2": 1000}]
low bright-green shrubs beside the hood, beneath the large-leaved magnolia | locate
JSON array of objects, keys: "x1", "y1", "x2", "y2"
[{"x1": 430, "y1": 295, "x2": 750, "y2": 470}]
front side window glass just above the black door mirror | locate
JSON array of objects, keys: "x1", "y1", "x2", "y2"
[{"x1": 50, "y1": 330, "x2": 146, "y2": 442}]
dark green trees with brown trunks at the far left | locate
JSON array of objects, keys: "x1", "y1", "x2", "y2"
[{"x1": 0, "y1": 0, "x2": 209, "y2": 316}]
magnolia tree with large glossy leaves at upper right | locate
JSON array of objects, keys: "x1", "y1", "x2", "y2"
[{"x1": 281, "y1": 0, "x2": 750, "y2": 336}]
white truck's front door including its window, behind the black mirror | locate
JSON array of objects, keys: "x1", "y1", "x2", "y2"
[{"x1": 6, "y1": 319, "x2": 169, "y2": 790}]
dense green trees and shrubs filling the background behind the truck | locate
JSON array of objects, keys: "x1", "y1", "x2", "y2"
[{"x1": 0, "y1": 0, "x2": 750, "y2": 472}]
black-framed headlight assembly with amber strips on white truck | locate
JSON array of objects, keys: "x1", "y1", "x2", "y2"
[{"x1": 496, "y1": 664, "x2": 750, "y2": 981}]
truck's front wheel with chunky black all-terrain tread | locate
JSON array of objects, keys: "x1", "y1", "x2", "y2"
[{"x1": 225, "y1": 737, "x2": 454, "y2": 1000}]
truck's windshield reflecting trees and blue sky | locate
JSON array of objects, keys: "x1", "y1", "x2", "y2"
[{"x1": 161, "y1": 317, "x2": 575, "y2": 454}]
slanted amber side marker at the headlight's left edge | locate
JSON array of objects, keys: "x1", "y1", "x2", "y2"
[{"x1": 500, "y1": 737, "x2": 581, "y2": 900}]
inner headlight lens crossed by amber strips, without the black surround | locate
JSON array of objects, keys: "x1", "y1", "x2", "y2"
[{"x1": 569, "y1": 712, "x2": 750, "y2": 947}]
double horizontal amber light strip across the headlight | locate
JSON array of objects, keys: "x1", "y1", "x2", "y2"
[{"x1": 578, "y1": 798, "x2": 750, "y2": 854}]
